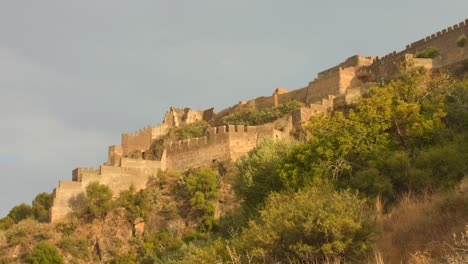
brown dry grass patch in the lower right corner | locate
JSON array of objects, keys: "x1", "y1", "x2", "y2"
[{"x1": 378, "y1": 179, "x2": 468, "y2": 264}]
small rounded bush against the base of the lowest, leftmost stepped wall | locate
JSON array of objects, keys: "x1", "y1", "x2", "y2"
[{"x1": 84, "y1": 182, "x2": 116, "y2": 219}]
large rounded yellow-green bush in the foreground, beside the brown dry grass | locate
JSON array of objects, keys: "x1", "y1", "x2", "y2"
[{"x1": 241, "y1": 185, "x2": 373, "y2": 262}]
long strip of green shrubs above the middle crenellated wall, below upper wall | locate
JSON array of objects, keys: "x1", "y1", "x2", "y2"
[{"x1": 217, "y1": 101, "x2": 300, "y2": 126}]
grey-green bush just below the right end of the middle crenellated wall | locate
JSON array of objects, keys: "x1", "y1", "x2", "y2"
[{"x1": 233, "y1": 141, "x2": 294, "y2": 214}]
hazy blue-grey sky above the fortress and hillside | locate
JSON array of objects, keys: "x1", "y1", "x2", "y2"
[{"x1": 0, "y1": 0, "x2": 468, "y2": 217}]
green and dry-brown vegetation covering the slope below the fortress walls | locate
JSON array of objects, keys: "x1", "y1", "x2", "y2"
[{"x1": 0, "y1": 69, "x2": 468, "y2": 263}]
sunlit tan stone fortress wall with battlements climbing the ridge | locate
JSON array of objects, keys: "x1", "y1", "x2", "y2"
[{"x1": 50, "y1": 19, "x2": 468, "y2": 222}]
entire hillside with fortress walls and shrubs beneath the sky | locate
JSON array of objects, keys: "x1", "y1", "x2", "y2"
[{"x1": 0, "y1": 20, "x2": 468, "y2": 263}]
